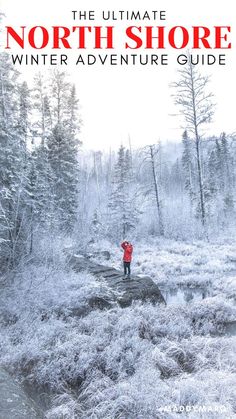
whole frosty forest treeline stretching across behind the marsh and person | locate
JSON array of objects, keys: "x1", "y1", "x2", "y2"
[{"x1": 0, "y1": 53, "x2": 236, "y2": 269}]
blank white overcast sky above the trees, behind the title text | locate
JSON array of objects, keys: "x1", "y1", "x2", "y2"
[{"x1": 0, "y1": 0, "x2": 236, "y2": 149}]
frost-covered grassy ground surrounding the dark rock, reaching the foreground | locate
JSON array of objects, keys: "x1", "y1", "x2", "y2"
[{"x1": 0, "y1": 240, "x2": 236, "y2": 419}]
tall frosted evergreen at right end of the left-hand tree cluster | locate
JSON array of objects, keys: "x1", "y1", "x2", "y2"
[{"x1": 47, "y1": 71, "x2": 80, "y2": 231}]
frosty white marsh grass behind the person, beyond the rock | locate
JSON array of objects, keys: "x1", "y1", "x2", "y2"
[{"x1": 91, "y1": 239, "x2": 236, "y2": 294}]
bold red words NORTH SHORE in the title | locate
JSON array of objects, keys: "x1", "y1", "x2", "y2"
[{"x1": 4, "y1": 25, "x2": 231, "y2": 50}]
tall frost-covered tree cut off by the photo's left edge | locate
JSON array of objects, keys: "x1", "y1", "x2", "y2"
[{"x1": 0, "y1": 53, "x2": 27, "y2": 266}]
